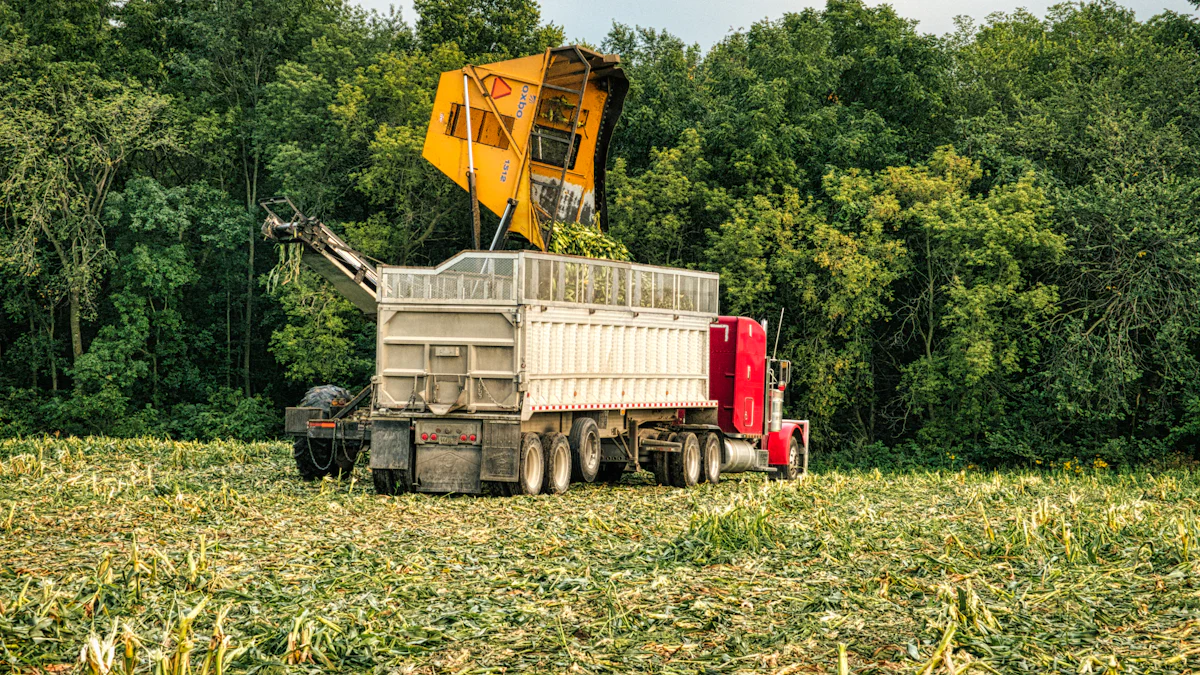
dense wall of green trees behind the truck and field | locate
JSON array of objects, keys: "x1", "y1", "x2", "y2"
[{"x1": 0, "y1": 0, "x2": 1200, "y2": 462}]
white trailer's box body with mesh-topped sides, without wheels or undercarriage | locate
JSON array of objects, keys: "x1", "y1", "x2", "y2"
[{"x1": 377, "y1": 251, "x2": 718, "y2": 418}]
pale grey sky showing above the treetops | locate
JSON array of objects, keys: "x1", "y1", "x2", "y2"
[{"x1": 356, "y1": 0, "x2": 1196, "y2": 49}]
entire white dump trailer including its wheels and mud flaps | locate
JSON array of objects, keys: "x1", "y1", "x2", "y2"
[{"x1": 370, "y1": 251, "x2": 719, "y2": 492}]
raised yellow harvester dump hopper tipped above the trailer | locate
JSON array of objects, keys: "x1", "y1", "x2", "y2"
[{"x1": 422, "y1": 47, "x2": 624, "y2": 250}]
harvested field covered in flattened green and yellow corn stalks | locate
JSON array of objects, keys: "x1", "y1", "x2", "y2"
[{"x1": 0, "y1": 438, "x2": 1200, "y2": 674}]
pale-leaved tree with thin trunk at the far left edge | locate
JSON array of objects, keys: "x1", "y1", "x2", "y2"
[{"x1": 0, "y1": 42, "x2": 175, "y2": 358}]
